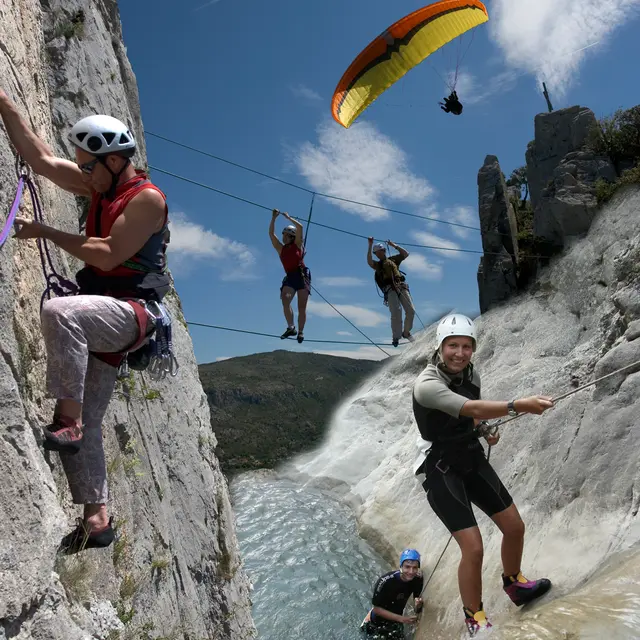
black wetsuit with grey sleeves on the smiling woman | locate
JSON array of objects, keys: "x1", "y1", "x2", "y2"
[{"x1": 413, "y1": 365, "x2": 513, "y2": 533}]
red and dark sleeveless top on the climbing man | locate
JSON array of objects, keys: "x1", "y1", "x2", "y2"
[{"x1": 85, "y1": 171, "x2": 169, "y2": 276}]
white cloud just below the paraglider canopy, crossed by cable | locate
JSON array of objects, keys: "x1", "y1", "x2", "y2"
[{"x1": 293, "y1": 122, "x2": 434, "y2": 220}]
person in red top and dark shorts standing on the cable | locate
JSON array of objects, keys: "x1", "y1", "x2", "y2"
[{"x1": 269, "y1": 209, "x2": 311, "y2": 342}]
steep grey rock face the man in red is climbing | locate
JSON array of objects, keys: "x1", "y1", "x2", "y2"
[{"x1": 0, "y1": 0, "x2": 254, "y2": 640}]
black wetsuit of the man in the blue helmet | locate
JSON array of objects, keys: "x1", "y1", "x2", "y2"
[{"x1": 363, "y1": 569, "x2": 423, "y2": 638}]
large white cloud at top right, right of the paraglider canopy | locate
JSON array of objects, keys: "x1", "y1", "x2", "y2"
[{"x1": 489, "y1": 0, "x2": 639, "y2": 95}]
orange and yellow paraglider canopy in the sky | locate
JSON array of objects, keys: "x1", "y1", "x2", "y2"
[{"x1": 331, "y1": 0, "x2": 489, "y2": 128}]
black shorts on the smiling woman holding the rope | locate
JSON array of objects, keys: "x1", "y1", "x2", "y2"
[{"x1": 422, "y1": 452, "x2": 513, "y2": 533}]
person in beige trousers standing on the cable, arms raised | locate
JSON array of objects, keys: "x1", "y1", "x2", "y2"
[{"x1": 367, "y1": 238, "x2": 416, "y2": 347}]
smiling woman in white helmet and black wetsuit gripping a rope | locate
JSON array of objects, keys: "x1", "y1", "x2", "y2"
[{"x1": 413, "y1": 314, "x2": 553, "y2": 636}]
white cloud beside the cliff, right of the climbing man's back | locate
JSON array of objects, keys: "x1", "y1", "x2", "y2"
[{"x1": 167, "y1": 213, "x2": 256, "y2": 280}]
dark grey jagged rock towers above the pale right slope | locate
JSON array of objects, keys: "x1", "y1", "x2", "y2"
[{"x1": 478, "y1": 106, "x2": 617, "y2": 313}]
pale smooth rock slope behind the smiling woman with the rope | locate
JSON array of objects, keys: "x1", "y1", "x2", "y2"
[{"x1": 291, "y1": 187, "x2": 640, "y2": 639}]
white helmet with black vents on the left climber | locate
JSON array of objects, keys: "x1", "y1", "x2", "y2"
[{"x1": 68, "y1": 115, "x2": 136, "y2": 158}]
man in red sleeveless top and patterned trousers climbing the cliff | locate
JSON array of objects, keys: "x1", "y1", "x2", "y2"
[{"x1": 0, "y1": 90, "x2": 170, "y2": 553}]
